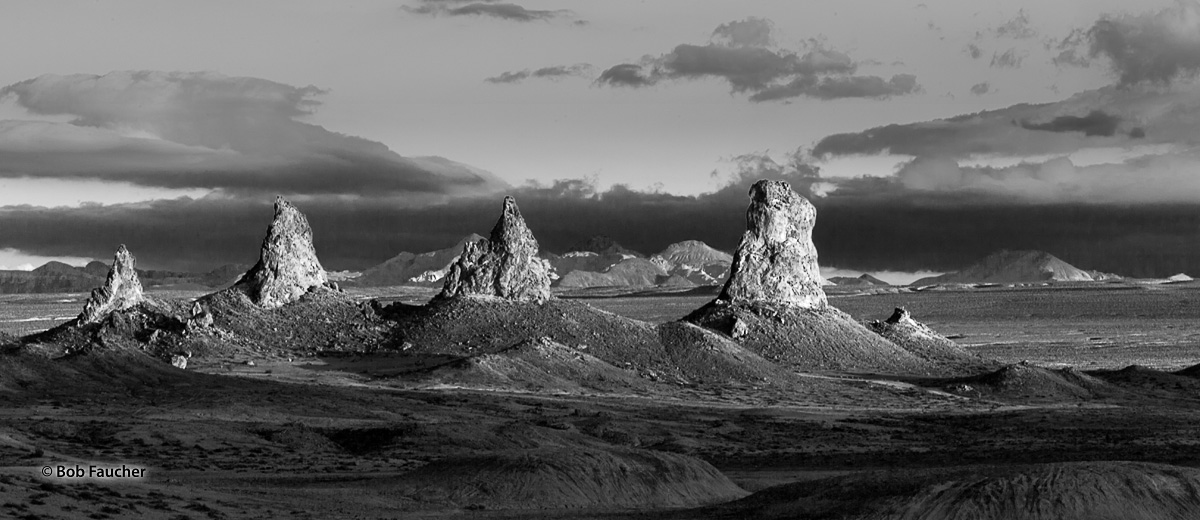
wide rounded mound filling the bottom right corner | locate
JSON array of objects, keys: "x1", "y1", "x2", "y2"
[{"x1": 705, "y1": 462, "x2": 1200, "y2": 520}]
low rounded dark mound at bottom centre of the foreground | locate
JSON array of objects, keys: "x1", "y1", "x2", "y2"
[{"x1": 395, "y1": 447, "x2": 745, "y2": 509}]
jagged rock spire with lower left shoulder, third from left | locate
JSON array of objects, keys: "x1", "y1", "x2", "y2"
[{"x1": 440, "y1": 197, "x2": 550, "y2": 303}]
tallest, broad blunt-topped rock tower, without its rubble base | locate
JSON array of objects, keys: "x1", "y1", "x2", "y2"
[{"x1": 718, "y1": 180, "x2": 827, "y2": 309}]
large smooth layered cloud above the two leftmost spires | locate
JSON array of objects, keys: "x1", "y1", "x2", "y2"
[{"x1": 0, "y1": 71, "x2": 505, "y2": 198}]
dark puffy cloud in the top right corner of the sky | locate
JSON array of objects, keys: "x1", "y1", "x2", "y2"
[{"x1": 1087, "y1": 0, "x2": 1200, "y2": 85}]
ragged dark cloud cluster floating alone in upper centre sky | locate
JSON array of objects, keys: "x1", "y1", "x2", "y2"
[{"x1": 596, "y1": 18, "x2": 920, "y2": 102}]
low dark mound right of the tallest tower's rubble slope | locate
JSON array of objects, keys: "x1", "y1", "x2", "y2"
[{"x1": 946, "y1": 364, "x2": 1120, "y2": 402}]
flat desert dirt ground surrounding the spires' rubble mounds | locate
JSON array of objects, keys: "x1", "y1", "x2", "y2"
[{"x1": 7, "y1": 283, "x2": 1200, "y2": 519}]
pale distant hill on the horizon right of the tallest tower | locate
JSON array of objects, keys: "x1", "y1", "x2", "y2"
[{"x1": 911, "y1": 250, "x2": 1094, "y2": 286}]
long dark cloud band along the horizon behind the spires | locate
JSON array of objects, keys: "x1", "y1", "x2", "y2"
[{"x1": 7, "y1": 159, "x2": 1200, "y2": 276}]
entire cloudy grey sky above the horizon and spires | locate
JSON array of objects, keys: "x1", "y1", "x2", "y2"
[{"x1": 0, "y1": 0, "x2": 1200, "y2": 276}]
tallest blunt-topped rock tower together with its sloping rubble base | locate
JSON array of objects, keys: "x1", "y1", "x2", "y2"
[{"x1": 684, "y1": 180, "x2": 932, "y2": 373}]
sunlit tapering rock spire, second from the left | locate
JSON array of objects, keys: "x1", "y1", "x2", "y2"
[{"x1": 234, "y1": 197, "x2": 329, "y2": 309}]
